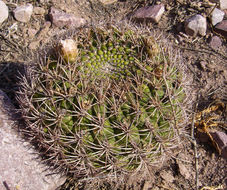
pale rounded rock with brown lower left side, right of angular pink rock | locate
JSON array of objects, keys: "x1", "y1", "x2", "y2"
[{"x1": 185, "y1": 14, "x2": 207, "y2": 36}]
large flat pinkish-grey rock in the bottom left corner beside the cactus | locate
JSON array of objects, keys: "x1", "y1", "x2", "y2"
[{"x1": 0, "y1": 90, "x2": 65, "y2": 190}]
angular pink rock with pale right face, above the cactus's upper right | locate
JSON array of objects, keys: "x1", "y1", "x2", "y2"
[{"x1": 133, "y1": 4, "x2": 165, "y2": 23}]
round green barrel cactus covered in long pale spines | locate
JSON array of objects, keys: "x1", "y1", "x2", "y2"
[{"x1": 18, "y1": 27, "x2": 185, "y2": 189}]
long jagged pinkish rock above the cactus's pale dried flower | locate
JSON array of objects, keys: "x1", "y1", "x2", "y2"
[{"x1": 49, "y1": 7, "x2": 86, "y2": 28}]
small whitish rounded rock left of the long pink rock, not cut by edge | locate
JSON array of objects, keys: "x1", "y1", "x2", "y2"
[{"x1": 13, "y1": 4, "x2": 33, "y2": 23}]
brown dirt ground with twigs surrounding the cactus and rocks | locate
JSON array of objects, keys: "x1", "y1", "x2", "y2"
[{"x1": 0, "y1": 0, "x2": 227, "y2": 190}]
